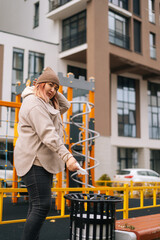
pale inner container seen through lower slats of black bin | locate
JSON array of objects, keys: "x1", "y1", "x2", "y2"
[{"x1": 72, "y1": 214, "x2": 111, "y2": 240}]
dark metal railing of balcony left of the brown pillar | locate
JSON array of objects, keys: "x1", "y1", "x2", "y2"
[{"x1": 62, "y1": 30, "x2": 86, "y2": 51}]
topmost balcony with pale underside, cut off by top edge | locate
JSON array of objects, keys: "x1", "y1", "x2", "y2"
[{"x1": 47, "y1": 0, "x2": 88, "y2": 20}]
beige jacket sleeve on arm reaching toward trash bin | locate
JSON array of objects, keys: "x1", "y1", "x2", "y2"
[{"x1": 28, "y1": 106, "x2": 72, "y2": 162}]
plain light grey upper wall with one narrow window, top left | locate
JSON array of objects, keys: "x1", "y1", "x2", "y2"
[{"x1": 0, "y1": 0, "x2": 59, "y2": 44}]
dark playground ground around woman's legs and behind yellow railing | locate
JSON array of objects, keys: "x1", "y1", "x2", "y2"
[{"x1": 0, "y1": 198, "x2": 160, "y2": 240}]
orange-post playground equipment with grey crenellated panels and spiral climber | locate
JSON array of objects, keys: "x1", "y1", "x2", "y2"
[{"x1": 1, "y1": 73, "x2": 99, "y2": 209}]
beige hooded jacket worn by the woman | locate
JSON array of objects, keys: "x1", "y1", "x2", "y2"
[{"x1": 14, "y1": 87, "x2": 72, "y2": 176}]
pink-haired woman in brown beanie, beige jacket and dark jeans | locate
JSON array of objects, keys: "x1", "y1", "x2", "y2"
[{"x1": 14, "y1": 67, "x2": 78, "y2": 240}]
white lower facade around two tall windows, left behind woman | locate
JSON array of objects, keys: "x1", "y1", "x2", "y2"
[{"x1": 0, "y1": 32, "x2": 58, "y2": 139}]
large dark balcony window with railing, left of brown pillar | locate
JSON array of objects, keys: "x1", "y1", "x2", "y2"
[{"x1": 62, "y1": 11, "x2": 86, "y2": 51}]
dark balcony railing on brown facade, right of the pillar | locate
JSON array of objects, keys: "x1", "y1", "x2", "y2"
[{"x1": 109, "y1": 29, "x2": 130, "y2": 50}]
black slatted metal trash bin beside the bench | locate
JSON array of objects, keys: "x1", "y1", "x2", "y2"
[{"x1": 64, "y1": 193, "x2": 122, "y2": 240}]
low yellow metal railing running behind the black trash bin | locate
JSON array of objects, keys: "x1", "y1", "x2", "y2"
[{"x1": 0, "y1": 184, "x2": 160, "y2": 224}]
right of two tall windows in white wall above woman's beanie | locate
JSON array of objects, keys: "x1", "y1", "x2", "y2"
[{"x1": 28, "y1": 51, "x2": 44, "y2": 78}]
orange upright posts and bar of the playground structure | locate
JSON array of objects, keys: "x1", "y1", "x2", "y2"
[{"x1": 0, "y1": 73, "x2": 94, "y2": 207}]
